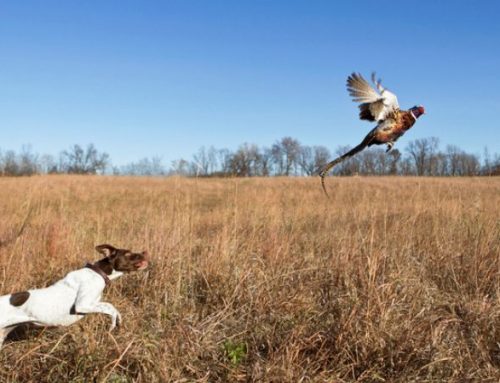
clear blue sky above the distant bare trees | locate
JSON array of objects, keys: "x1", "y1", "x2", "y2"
[{"x1": 0, "y1": 0, "x2": 500, "y2": 165}]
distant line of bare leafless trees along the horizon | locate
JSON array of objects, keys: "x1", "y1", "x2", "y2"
[{"x1": 0, "y1": 137, "x2": 500, "y2": 177}]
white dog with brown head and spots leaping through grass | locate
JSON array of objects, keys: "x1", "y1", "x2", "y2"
[{"x1": 0, "y1": 244, "x2": 149, "y2": 348}]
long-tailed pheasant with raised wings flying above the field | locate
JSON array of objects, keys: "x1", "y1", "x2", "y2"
[{"x1": 319, "y1": 72, "x2": 425, "y2": 196}]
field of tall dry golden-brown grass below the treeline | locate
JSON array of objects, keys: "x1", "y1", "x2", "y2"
[{"x1": 0, "y1": 176, "x2": 500, "y2": 382}]
